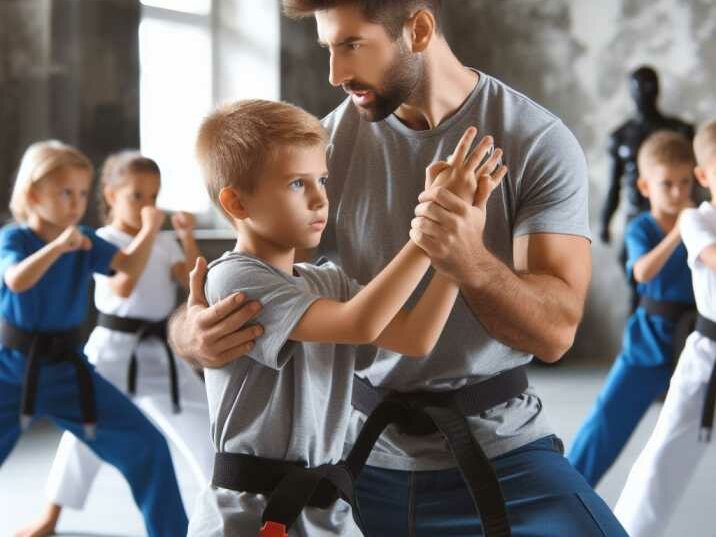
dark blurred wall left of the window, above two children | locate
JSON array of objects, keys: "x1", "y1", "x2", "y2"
[{"x1": 0, "y1": 0, "x2": 140, "y2": 223}]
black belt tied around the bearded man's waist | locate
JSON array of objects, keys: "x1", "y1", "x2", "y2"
[{"x1": 346, "y1": 366, "x2": 529, "y2": 537}]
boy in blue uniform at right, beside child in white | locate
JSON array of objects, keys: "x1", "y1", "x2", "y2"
[{"x1": 568, "y1": 131, "x2": 695, "y2": 486}]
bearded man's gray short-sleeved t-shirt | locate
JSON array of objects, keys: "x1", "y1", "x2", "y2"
[{"x1": 321, "y1": 73, "x2": 590, "y2": 470}]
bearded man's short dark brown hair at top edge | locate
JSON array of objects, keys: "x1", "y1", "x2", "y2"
[{"x1": 283, "y1": 0, "x2": 442, "y2": 40}]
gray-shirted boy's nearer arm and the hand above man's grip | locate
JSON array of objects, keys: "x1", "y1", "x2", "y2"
[{"x1": 290, "y1": 128, "x2": 490, "y2": 344}]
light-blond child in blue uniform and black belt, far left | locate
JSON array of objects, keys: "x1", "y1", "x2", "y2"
[{"x1": 0, "y1": 141, "x2": 187, "y2": 537}]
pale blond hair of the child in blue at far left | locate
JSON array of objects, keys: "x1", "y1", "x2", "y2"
[{"x1": 10, "y1": 140, "x2": 92, "y2": 223}]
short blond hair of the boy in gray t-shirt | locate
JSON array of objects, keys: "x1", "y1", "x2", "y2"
[{"x1": 196, "y1": 99, "x2": 327, "y2": 217}]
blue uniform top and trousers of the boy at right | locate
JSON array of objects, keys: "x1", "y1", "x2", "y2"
[{"x1": 567, "y1": 212, "x2": 695, "y2": 486}]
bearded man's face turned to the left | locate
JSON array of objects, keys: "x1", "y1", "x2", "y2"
[{"x1": 316, "y1": 4, "x2": 423, "y2": 121}]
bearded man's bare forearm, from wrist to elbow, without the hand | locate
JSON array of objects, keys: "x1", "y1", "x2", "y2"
[{"x1": 460, "y1": 252, "x2": 583, "y2": 362}]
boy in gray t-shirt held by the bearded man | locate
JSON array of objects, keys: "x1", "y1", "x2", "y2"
[{"x1": 189, "y1": 100, "x2": 506, "y2": 537}]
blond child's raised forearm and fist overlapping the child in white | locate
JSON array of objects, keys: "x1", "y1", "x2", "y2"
[{"x1": 109, "y1": 207, "x2": 164, "y2": 298}]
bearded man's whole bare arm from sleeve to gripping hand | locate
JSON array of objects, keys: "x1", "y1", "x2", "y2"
[{"x1": 413, "y1": 185, "x2": 591, "y2": 362}]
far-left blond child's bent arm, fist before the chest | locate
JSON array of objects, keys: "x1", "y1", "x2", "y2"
[{"x1": 3, "y1": 226, "x2": 92, "y2": 293}]
